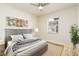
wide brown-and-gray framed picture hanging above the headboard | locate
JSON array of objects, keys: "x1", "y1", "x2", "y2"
[{"x1": 6, "y1": 17, "x2": 28, "y2": 27}]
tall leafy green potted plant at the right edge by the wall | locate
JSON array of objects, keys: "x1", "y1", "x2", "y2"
[{"x1": 70, "y1": 24, "x2": 79, "y2": 48}]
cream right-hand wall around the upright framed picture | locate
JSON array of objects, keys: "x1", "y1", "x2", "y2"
[{"x1": 38, "y1": 7, "x2": 77, "y2": 43}]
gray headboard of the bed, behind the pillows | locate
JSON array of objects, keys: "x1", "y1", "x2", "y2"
[{"x1": 5, "y1": 29, "x2": 33, "y2": 47}]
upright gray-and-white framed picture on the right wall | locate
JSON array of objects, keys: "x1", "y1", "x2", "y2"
[{"x1": 48, "y1": 17, "x2": 59, "y2": 33}]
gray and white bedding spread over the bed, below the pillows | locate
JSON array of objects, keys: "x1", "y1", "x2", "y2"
[{"x1": 5, "y1": 39, "x2": 48, "y2": 56}]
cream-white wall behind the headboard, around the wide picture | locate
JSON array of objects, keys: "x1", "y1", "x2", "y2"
[{"x1": 0, "y1": 4, "x2": 37, "y2": 39}]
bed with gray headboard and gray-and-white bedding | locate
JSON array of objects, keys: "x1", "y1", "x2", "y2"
[{"x1": 4, "y1": 29, "x2": 48, "y2": 56}]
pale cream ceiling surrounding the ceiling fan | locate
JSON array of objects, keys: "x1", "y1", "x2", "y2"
[{"x1": 9, "y1": 3, "x2": 77, "y2": 15}]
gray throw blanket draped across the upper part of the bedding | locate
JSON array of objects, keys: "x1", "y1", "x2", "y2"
[{"x1": 12, "y1": 39, "x2": 40, "y2": 52}]
